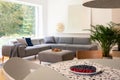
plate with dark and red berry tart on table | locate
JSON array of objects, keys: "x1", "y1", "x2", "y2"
[{"x1": 70, "y1": 65, "x2": 101, "y2": 75}]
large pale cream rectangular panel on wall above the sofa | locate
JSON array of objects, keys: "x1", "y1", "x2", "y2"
[{"x1": 68, "y1": 4, "x2": 91, "y2": 33}]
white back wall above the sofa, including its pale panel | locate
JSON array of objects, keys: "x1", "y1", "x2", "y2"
[{"x1": 16, "y1": 0, "x2": 112, "y2": 35}]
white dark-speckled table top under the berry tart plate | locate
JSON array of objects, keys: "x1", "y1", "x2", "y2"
[{"x1": 47, "y1": 59, "x2": 120, "y2": 80}]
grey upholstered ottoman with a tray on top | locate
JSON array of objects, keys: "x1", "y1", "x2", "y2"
[{"x1": 38, "y1": 49, "x2": 74, "y2": 63}]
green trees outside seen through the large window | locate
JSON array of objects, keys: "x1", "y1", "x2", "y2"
[{"x1": 0, "y1": 0, "x2": 35, "y2": 37}]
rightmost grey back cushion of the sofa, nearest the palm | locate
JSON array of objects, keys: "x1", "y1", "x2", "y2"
[{"x1": 73, "y1": 37, "x2": 91, "y2": 44}]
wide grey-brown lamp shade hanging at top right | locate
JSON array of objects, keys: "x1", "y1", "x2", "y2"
[{"x1": 83, "y1": 0, "x2": 120, "y2": 8}]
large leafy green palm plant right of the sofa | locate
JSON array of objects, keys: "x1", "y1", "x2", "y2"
[{"x1": 90, "y1": 24, "x2": 117, "y2": 57}]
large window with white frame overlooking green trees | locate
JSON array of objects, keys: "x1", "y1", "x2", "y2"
[{"x1": 0, "y1": 1, "x2": 41, "y2": 54}]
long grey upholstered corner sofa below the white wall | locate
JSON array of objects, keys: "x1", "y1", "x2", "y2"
[{"x1": 2, "y1": 36, "x2": 98, "y2": 57}]
